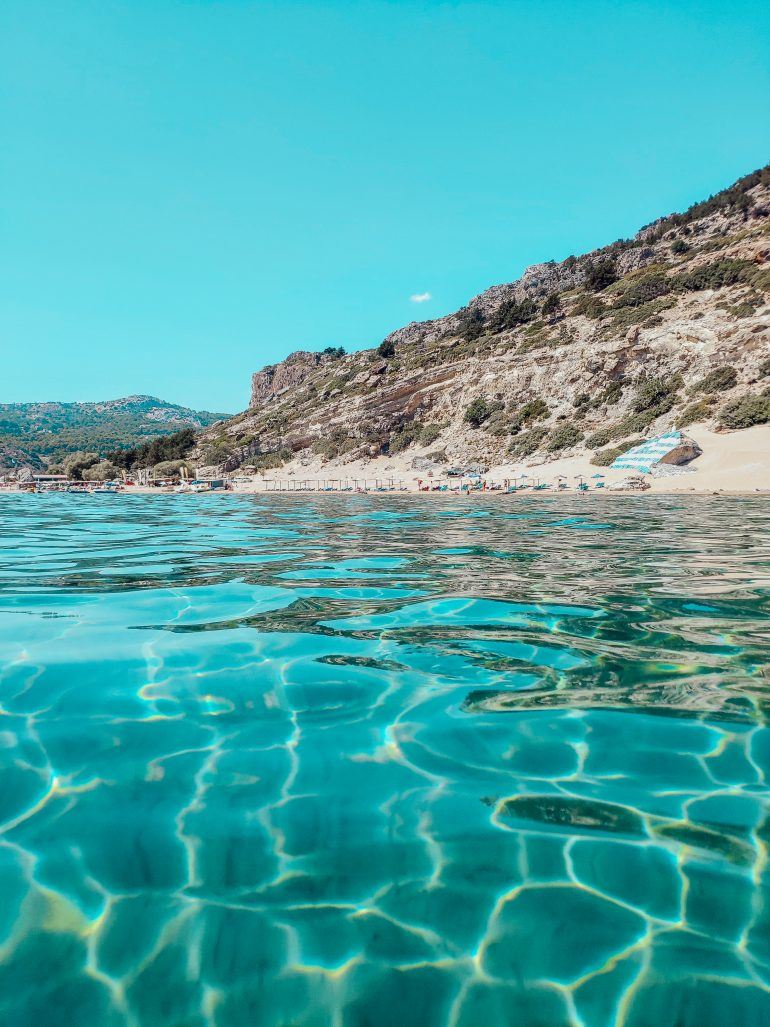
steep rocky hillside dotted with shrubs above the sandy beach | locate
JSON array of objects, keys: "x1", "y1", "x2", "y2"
[{"x1": 195, "y1": 165, "x2": 770, "y2": 469}]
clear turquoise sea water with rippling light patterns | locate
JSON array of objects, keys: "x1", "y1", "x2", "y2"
[{"x1": 0, "y1": 495, "x2": 770, "y2": 1027}]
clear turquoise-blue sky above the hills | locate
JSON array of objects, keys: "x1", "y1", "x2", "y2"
[{"x1": 0, "y1": 0, "x2": 770, "y2": 412}]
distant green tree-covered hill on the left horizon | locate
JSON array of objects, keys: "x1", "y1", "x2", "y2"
[{"x1": 0, "y1": 395, "x2": 228, "y2": 467}]
